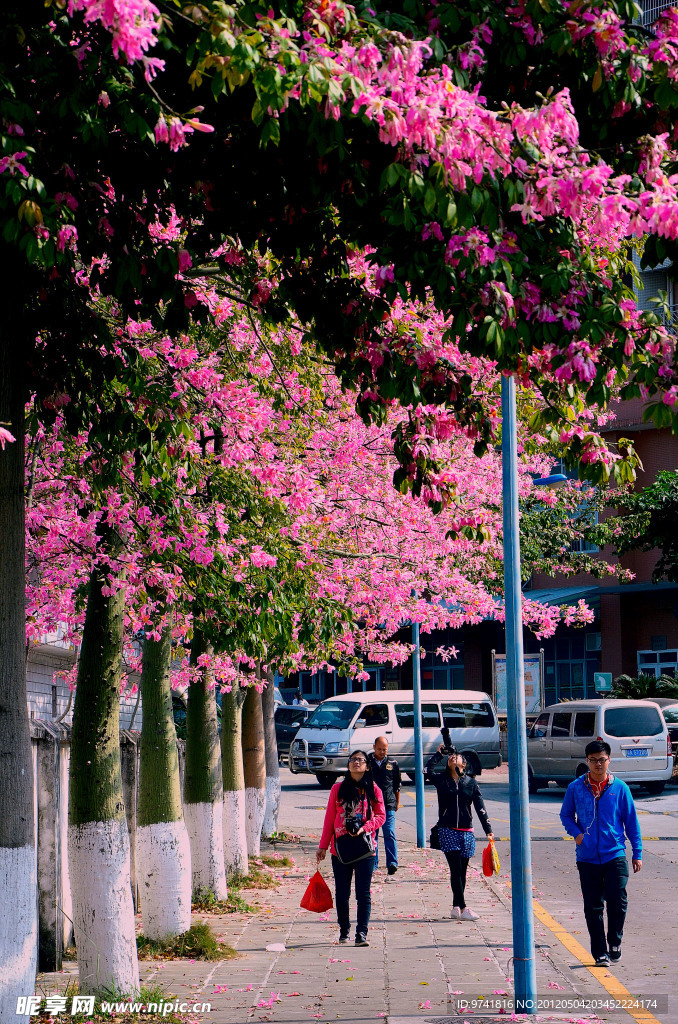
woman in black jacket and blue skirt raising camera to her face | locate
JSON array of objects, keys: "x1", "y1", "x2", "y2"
[{"x1": 426, "y1": 743, "x2": 494, "y2": 921}]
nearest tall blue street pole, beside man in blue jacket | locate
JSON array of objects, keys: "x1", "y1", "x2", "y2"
[{"x1": 502, "y1": 377, "x2": 537, "y2": 1014}]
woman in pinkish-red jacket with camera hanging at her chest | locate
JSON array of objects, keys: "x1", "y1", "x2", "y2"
[{"x1": 315, "y1": 751, "x2": 386, "y2": 946}]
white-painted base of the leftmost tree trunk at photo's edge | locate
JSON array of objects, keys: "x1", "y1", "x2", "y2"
[{"x1": 0, "y1": 846, "x2": 38, "y2": 1024}]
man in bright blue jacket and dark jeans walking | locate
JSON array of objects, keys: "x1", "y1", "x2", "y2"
[{"x1": 560, "y1": 739, "x2": 642, "y2": 967}]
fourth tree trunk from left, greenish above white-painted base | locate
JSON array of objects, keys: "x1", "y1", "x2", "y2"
[{"x1": 183, "y1": 623, "x2": 226, "y2": 899}]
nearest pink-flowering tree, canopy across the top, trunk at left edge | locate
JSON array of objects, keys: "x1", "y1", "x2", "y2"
[{"x1": 0, "y1": 0, "x2": 678, "y2": 1001}]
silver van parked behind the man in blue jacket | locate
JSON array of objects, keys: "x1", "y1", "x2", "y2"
[{"x1": 527, "y1": 698, "x2": 673, "y2": 796}]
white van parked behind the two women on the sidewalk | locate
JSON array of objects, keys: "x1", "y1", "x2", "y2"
[{"x1": 290, "y1": 690, "x2": 502, "y2": 787}]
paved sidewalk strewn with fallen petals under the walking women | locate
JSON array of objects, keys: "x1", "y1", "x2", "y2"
[{"x1": 39, "y1": 836, "x2": 654, "y2": 1024}]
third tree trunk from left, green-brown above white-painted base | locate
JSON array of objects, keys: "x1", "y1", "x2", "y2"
[{"x1": 136, "y1": 625, "x2": 192, "y2": 939}]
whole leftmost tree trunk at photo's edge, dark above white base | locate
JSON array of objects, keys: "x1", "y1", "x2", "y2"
[{"x1": 0, "y1": 333, "x2": 38, "y2": 1007}]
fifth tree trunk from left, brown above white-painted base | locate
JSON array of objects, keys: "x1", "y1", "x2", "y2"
[{"x1": 221, "y1": 684, "x2": 250, "y2": 874}]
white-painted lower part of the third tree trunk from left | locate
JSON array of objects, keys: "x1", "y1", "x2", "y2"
[{"x1": 136, "y1": 821, "x2": 192, "y2": 939}]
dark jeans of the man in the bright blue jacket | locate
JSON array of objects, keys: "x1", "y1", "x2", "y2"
[{"x1": 577, "y1": 857, "x2": 629, "y2": 958}]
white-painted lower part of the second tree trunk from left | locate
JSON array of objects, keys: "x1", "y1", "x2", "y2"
[{"x1": 69, "y1": 818, "x2": 139, "y2": 995}]
